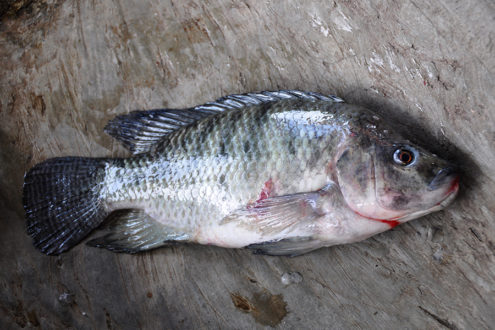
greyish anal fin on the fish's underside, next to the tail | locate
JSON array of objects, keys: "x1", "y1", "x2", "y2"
[{"x1": 86, "y1": 210, "x2": 189, "y2": 253}]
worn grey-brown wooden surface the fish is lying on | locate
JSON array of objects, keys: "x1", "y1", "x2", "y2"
[{"x1": 0, "y1": 0, "x2": 495, "y2": 329}]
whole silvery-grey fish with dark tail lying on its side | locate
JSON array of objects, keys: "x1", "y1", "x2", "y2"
[{"x1": 23, "y1": 90, "x2": 460, "y2": 256}]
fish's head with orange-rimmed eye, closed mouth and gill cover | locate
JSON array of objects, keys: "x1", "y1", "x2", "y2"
[{"x1": 336, "y1": 137, "x2": 459, "y2": 223}]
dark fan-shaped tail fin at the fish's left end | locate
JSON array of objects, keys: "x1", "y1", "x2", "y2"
[{"x1": 23, "y1": 157, "x2": 107, "y2": 255}]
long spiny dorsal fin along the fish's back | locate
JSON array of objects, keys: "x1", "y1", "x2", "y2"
[{"x1": 105, "y1": 90, "x2": 344, "y2": 154}]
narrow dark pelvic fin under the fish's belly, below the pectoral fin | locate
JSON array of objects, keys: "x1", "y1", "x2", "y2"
[{"x1": 246, "y1": 237, "x2": 323, "y2": 257}]
